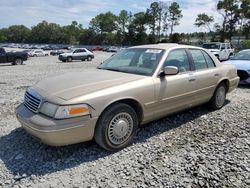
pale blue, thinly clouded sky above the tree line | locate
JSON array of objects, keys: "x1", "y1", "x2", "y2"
[{"x1": 0, "y1": 0, "x2": 220, "y2": 33}]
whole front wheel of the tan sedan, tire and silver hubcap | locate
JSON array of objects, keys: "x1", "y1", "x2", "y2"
[{"x1": 94, "y1": 103, "x2": 139, "y2": 151}]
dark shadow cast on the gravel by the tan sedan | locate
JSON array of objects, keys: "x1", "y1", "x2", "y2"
[{"x1": 0, "y1": 100, "x2": 230, "y2": 176}]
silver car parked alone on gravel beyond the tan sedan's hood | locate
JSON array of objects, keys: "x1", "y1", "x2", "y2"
[{"x1": 58, "y1": 48, "x2": 94, "y2": 62}]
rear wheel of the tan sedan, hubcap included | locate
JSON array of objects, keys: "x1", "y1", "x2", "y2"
[{"x1": 208, "y1": 83, "x2": 227, "y2": 110}]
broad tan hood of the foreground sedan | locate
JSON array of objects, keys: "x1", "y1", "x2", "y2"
[{"x1": 34, "y1": 69, "x2": 145, "y2": 100}]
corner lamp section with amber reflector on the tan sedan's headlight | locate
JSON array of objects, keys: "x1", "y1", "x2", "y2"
[{"x1": 55, "y1": 104, "x2": 90, "y2": 119}]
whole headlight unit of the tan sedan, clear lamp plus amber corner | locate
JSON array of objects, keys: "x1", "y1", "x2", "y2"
[{"x1": 40, "y1": 102, "x2": 90, "y2": 119}]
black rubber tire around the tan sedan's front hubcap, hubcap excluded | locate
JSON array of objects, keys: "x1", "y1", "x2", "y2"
[{"x1": 95, "y1": 103, "x2": 138, "y2": 151}]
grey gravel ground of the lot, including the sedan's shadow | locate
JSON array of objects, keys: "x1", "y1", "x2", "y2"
[{"x1": 0, "y1": 52, "x2": 250, "y2": 187}]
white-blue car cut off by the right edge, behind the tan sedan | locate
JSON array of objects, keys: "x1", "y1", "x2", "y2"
[{"x1": 225, "y1": 49, "x2": 250, "y2": 84}]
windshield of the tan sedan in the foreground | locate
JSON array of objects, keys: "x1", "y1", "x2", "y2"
[{"x1": 98, "y1": 48, "x2": 164, "y2": 76}]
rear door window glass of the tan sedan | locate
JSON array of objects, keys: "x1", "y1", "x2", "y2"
[{"x1": 189, "y1": 49, "x2": 208, "y2": 70}]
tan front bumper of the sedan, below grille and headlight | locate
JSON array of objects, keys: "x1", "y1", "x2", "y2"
[{"x1": 16, "y1": 104, "x2": 97, "y2": 146}]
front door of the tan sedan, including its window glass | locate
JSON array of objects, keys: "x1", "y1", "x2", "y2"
[{"x1": 154, "y1": 49, "x2": 195, "y2": 117}]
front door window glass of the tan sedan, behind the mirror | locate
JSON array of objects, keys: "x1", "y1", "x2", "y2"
[{"x1": 164, "y1": 49, "x2": 190, "y2": 72}]
